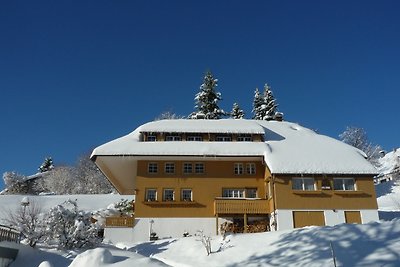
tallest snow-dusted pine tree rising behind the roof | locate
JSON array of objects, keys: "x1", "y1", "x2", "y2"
[{"x1": 189, "y1": 71, "x2": 225, "y2": 119}]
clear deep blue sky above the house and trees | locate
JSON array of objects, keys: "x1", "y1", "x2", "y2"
[{"x1": 0, "y1": 0, "x2": 400, "y2": 188}]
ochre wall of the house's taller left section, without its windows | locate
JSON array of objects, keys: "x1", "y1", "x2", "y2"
[{"x1": 135, "y1": 158, "x2": 266, "y2": 217}]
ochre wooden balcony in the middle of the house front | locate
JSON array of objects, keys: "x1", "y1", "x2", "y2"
[{"x1": 214, "y1": 198, "x2": 270, "y2": 214}]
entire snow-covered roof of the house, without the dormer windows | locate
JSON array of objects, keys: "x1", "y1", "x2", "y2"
[{"x1": 92, "y1": 119, "x2": 377, "y2": 174}]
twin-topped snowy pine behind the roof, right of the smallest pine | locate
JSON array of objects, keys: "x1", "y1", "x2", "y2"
[{"x1": 252, "y1": 84, "x2": 278, "y2": 120}]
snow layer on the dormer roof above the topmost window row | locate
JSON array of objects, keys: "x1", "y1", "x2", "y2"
[{"x1": 138, "y1": 119, "x2": 264, "y2": 134}]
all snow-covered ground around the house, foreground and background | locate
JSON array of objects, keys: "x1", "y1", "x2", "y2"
[{"x1": 0, "y1": 187, "x2": 400, "y2": 267}]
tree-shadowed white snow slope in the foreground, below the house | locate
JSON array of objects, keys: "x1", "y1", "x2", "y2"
[{"x1": 130, "y1": 220, "x2": 400, "y2": 267}]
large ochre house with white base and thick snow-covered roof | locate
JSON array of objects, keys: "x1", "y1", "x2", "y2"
[{"x1": 91, "y1": 119, "x2": 378, "y2": 241}]
